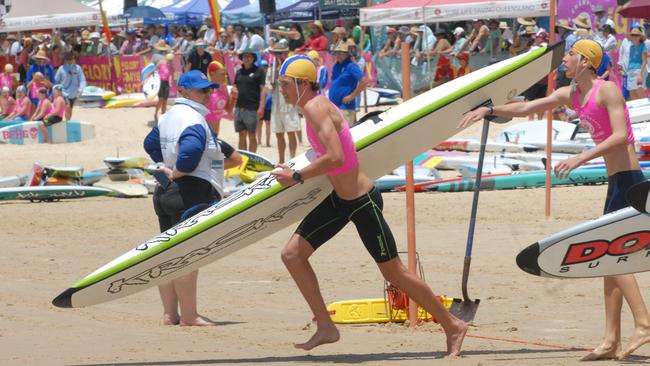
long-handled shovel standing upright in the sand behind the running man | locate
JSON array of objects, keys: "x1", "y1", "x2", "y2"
[{"x1": 449, "y1": 101, "x2": 510, "y2": 322}]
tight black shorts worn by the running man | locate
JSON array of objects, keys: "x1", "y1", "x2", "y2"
[{"x1": 296, "y1": 187, "x2": 397, "y2": 263}]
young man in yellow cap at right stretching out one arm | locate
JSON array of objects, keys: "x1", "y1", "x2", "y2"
[{"x1": 459, "y1": 40, "x2": 650, "y2": 361}]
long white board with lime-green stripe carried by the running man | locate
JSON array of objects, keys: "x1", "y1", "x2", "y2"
[{"x1": 53, "y1": 43, "x2": 564, "y2": 308}]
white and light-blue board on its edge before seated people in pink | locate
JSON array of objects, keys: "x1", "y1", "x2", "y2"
[{"x1": 0, "y1": 121, "x2": 95, "y2": 145}]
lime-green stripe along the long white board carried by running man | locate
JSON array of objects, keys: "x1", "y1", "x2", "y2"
[{"x1": 72, "y1": 47, "x2": 551, "y2": 288}]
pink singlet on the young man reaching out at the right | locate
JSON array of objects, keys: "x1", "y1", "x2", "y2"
[{"x1": 571, "y1": 80, "x2": 634, "y2": 144}]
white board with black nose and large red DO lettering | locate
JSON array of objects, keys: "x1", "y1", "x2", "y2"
[{"x1": 517, "y1": 207, "x2": 650, "y2": 278}]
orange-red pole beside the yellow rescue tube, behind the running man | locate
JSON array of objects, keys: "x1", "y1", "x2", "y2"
[{"x1": 402, "y1": 42, "x2": 418, "y2": 327}]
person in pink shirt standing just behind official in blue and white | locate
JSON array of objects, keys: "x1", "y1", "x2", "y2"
[{"x1": 205, "y1": 61, "x2": 237, "y2": 136}]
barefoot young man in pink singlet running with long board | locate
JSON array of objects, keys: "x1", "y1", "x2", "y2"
[{"x1": 272, "y1": 55, "x2": 467, "y2": 357}]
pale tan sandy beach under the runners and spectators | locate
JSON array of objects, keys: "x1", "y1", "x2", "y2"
[{"x1": 0, "y1": 103, "x2": 650, "y2": 365}]
